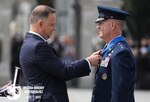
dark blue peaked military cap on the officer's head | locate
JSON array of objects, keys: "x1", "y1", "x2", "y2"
[{"x1": 95, "y1": 6, "x2": 129, "y2": 23}]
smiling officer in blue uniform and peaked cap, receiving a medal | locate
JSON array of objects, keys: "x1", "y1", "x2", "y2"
[{"x1": 92, "y1": 6, "x2": 136, "y2": 102}]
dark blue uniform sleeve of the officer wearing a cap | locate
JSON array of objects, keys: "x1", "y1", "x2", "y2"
[{"x1": 111, "y1": 51, "x2": 134, "y2": 102}]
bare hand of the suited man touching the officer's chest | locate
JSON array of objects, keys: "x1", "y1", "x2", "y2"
[{"x1": 87, "y1": 50, "x2": 102, "y2": 66}]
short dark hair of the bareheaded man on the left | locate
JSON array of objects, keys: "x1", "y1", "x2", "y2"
[{"x1": 30, "y1": 5, "x2": 56, "y2": 24}]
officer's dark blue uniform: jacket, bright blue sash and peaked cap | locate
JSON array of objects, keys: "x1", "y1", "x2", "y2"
[{"x1": 92, "y1": 6, "x2": 136, "y2": 102}]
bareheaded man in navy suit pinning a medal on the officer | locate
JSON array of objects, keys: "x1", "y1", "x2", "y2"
[{"x1": 20, "y1": 5, "x2": 101, "y2": 102}]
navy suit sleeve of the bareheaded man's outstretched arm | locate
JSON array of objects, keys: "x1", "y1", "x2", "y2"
[{"x1": 35, "y1": 43, "x2": 90, "y2": 80}]
